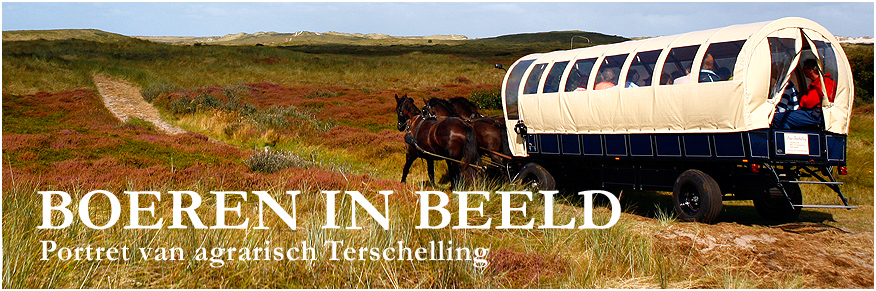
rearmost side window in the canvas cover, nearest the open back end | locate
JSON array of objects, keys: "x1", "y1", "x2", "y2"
[{"x1": 699, "y1": 40, "x2": 745, "y2": 83}]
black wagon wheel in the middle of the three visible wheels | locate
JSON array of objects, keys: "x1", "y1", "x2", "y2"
[{"x1": 672, "y1": 169, "x2": 724, "y2": 223}]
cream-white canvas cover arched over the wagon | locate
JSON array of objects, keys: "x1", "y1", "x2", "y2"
[{"x1": 502, "y1": 17, "x2": 854, "y2": 140}]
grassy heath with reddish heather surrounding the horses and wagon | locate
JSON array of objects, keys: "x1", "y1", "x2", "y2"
[{"x1": 2, "y1": 32, "x2": 873, "y2": 288}]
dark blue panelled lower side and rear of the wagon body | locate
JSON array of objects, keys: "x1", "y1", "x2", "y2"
[{"x1": 525, "y1": 129, "x2": 846, "y2": 166}]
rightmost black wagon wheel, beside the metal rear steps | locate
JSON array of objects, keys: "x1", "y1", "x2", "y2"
[{"x1": 753, "y1": 184, "x2": 803, "y2": 222}]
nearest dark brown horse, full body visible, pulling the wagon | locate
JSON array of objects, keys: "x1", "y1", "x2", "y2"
[{"x1": 395, "y1": 95, "x2": 478, "y2": 189}]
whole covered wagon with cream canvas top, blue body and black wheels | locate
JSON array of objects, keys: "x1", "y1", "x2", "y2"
[{"x1": 502, "y1": 17, "x2": 854, "y2": 222}]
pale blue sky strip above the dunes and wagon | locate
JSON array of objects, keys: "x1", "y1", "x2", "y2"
[{"x1": 2, "y1": 2, "x2": 874, "y2": 38}]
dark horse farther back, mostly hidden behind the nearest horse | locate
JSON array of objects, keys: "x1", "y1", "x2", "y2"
[{"x1": 423, "y1": 97, "x2": 511, "y2": 171}]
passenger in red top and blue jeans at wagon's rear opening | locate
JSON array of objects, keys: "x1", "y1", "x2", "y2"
[{"x1": 771, "y1": 59, "x2": 836, "y2": 129}]
